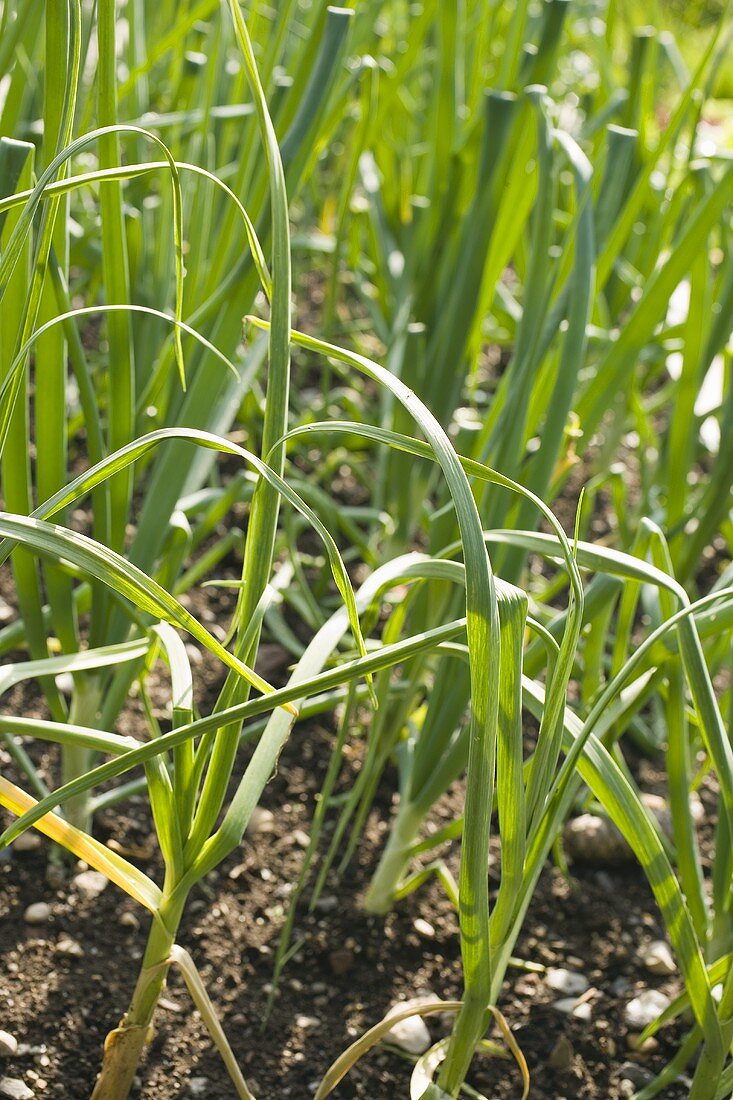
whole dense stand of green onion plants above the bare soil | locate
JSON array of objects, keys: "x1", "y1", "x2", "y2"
[{"x1": 0, "y1": 0, "x2": 733, "y2": 1100}]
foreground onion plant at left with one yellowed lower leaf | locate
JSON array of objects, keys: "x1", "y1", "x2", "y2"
[{"x1": 0, "y1": 3, "x2": 369, "y2": 1098}]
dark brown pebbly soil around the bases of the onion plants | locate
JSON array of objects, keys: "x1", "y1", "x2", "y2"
[{"x1": 0, "y1": 677, "x2": 688, "y2": 1100}]
